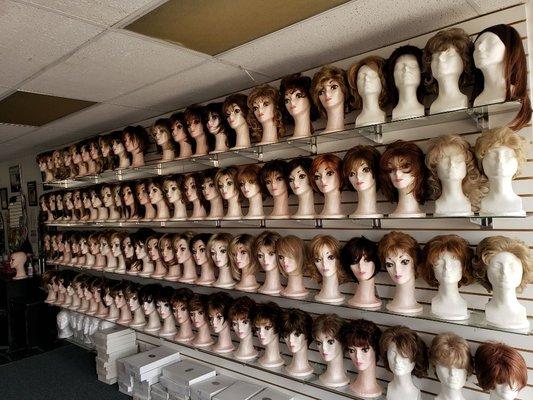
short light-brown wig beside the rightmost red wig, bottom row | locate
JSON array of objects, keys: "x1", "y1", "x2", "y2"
[{"x1": 429, "y1": 332, "x2": 474, "y2": 375}]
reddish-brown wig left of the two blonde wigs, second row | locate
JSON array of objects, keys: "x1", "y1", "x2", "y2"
[{"x1": 379, "y1": 140, "x2": 428, "y2": 204}]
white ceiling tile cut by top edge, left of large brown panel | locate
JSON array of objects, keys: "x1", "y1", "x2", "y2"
[{"x1": 21, "y1": 0, "x2": 162, "y2": 26}]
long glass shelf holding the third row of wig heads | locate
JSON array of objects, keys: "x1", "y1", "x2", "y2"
[{"x1": 50, "y1": 263, "x2": 533, "y2": 342}]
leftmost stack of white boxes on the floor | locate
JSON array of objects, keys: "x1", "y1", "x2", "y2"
[{"x1": 93, "y1": 325, "x2": 137, "y2": 384}]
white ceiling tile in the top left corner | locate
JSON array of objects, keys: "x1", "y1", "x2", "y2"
[{"x1": 0, "y1": 0, "x2": 102, "y2": 87}]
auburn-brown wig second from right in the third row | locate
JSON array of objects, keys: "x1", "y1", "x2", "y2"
[{"x1": 418, "y1": 235, "x2": 474, "y2": 287}]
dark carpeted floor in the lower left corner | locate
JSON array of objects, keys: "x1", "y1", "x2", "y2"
[{"x1": 0, "y1": 345, "x2": 131, "y2": 400}]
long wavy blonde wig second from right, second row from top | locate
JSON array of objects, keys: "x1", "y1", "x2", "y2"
[{"x1": 426, "y1": 134, "x2": 488, "y2": 211}]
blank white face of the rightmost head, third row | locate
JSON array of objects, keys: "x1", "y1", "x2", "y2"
[{"x1": 487, "y1": 251, "x2": 524, "y2": 291}]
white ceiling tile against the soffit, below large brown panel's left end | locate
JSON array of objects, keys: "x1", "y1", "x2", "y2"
[{"x1": 112, "y1": 61, "x2": 271, "y2": 112}]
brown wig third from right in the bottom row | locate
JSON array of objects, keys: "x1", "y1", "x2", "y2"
[{"x1": 379, "y1": 326, "x2": 429, "y2": 378}]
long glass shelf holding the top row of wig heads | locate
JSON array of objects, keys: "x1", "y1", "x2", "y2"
[{"x1": 45, "y1": 101, "x2": 521, "y2": 189}]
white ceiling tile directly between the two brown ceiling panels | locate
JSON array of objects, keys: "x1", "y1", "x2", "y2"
[{"x1": 24, "y1": 32, "x2": 205, "y2": 101}]
